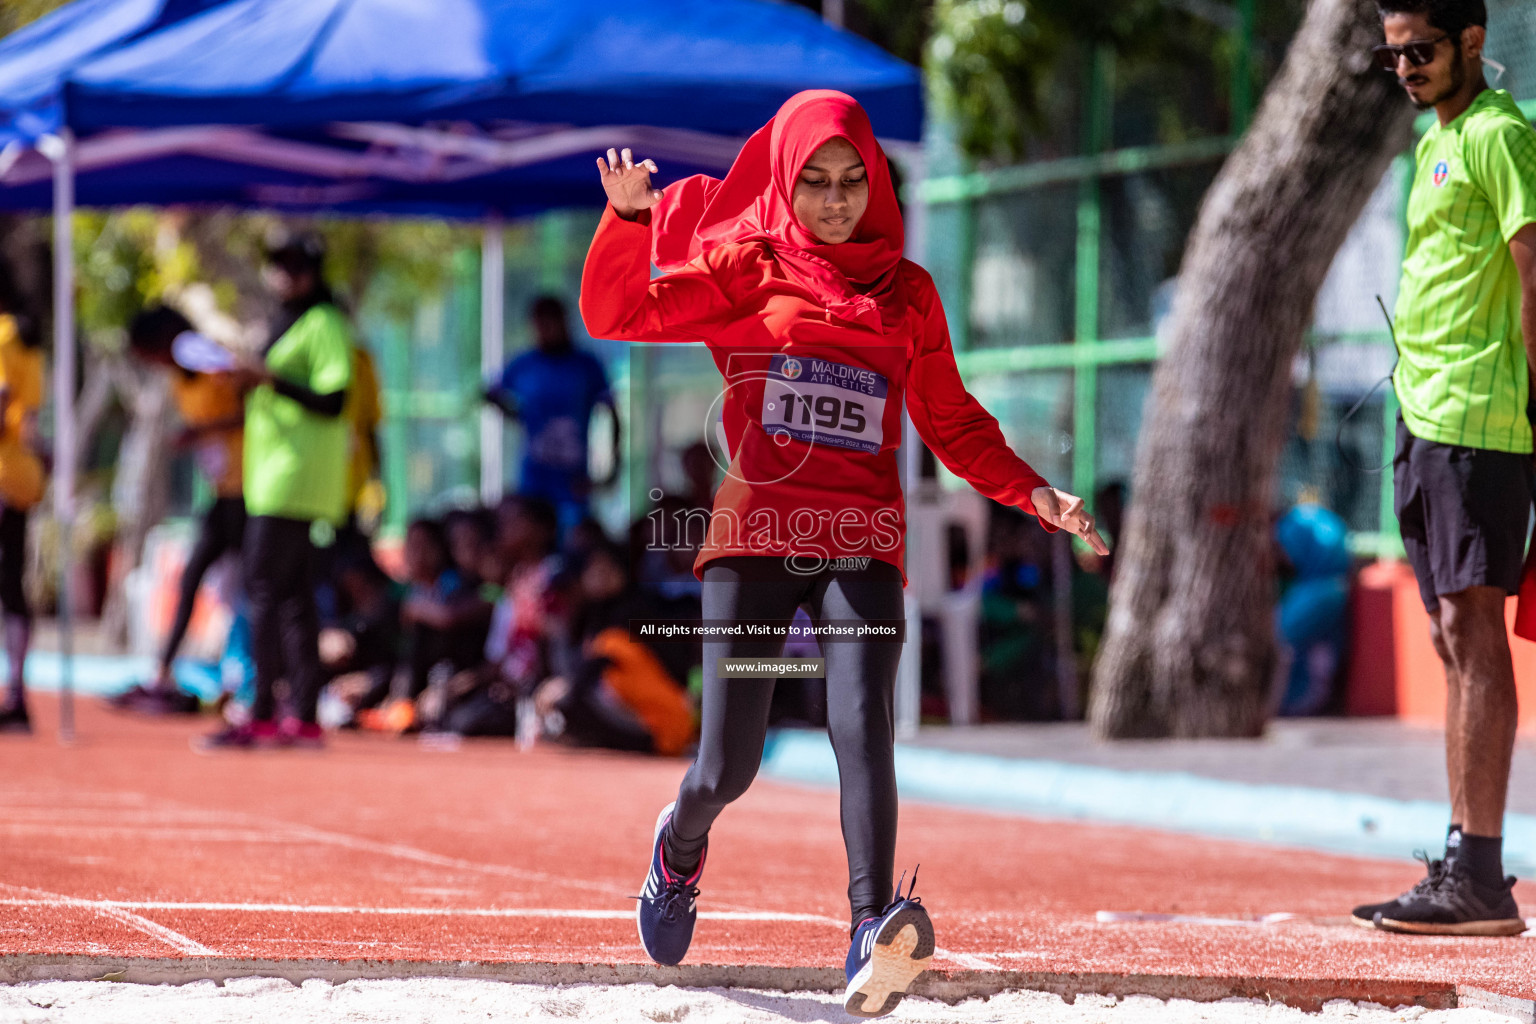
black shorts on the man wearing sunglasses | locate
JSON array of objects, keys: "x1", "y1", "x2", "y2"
[{"x1": 1392, "y1": 416, "x2": 1533, "y2": 613}]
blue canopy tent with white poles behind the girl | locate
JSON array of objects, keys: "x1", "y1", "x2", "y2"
[{"x1": 0, "y1": 0, "x2": 922, "y2": 736}]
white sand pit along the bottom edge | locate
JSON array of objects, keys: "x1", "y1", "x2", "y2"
[{"x1": 0, "y1": 978, "x2": 1510, "y2": 1024}]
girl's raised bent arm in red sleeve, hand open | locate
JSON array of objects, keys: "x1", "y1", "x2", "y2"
[{"x1": 581, "y1": 149, "x2": 731, "y2": 341}]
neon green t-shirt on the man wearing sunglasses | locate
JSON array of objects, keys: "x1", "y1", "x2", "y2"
[{"x1": 1393, "y1": 89, "x2": 1536, "y2": 451}]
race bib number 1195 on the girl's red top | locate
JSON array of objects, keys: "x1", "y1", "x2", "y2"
[{"x1": 762, "y1": 353, "x2": 886, "y2": 454}]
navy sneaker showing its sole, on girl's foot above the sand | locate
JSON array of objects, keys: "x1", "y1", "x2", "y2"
[{"x1": 843, "y1": 870, "x2": 934, "y2": 1016}]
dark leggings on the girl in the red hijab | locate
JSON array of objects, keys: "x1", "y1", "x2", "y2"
[{"x1": 667, "y1": 556, "x2": 903, "y2": 924}]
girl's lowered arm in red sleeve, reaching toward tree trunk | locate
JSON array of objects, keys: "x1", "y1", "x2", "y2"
[{"x1": 906, "y1": 276, "x2": 1109, "y2": 554}]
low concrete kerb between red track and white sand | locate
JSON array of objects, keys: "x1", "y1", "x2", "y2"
[{"x1": 0, "y1": 953, "x2": 1511, "y2": 1024}]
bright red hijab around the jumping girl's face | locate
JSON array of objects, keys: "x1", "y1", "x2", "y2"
[{"x1": 651, "y1": 89, "x2": 906, "y2": 332}]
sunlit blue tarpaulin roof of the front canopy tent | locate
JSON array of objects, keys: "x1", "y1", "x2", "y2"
[{"x1": 65, "y1": 0, "x2": 922, "y2": 140}]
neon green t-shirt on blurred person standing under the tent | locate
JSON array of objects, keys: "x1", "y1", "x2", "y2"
[{"x1": 246, "y1": 304, "x2": 352, "y2": 524}]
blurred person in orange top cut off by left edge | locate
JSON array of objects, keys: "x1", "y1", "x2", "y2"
[{"x1": 0, "y1": 261, "x2": 46, "y2": 732}]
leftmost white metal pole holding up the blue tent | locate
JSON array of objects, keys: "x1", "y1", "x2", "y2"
[{"x1": 38, "y1": 127, "x2": 75, "y2": 743}]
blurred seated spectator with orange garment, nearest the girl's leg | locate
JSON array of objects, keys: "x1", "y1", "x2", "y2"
[{"x1": 535, "y1": 545, "x2": 694, "y2": 755}]
